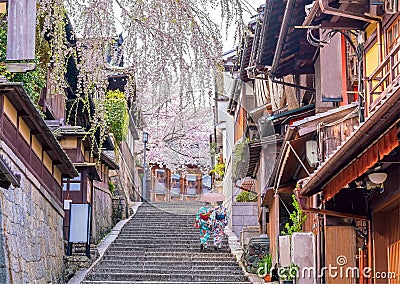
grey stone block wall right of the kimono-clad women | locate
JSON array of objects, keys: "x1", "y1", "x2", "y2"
[{"x1": 231, "y1": 202, "x2": 258, "y2": 237}]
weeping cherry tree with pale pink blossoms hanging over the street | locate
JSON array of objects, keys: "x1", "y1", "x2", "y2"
[{"x1": 38, "y1": 0, "x2": 255, "y2": 169}]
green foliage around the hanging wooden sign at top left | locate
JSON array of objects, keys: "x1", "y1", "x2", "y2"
[{"x1": 0, "y1": 19, "x2": 46, "y2": 105}]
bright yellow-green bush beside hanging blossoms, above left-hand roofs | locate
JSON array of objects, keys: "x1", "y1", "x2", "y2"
[{"x1": 105, "y1": 90, "x2": 129, "y2": 144}]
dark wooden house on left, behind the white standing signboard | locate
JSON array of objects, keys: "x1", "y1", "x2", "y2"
[{"x1": 39, "y1": 21, "x2": 128, "y2": 244}]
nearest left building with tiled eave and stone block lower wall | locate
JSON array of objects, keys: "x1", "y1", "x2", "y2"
[{"x1": 0, "y1": 81, "x2": 78, "y2": 283}]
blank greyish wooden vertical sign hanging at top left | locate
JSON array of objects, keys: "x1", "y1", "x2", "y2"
[{"x1": 7, "y1": 0, "x2": 36, "y2": 60}]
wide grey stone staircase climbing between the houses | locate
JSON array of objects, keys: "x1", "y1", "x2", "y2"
[{"x1": 82, "y1": 202, "x2": 251, "y2": 284}]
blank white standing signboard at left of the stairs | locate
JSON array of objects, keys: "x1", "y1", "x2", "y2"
[{"x1": 68, "y1": 203, "x2": 91, "y2": 243}]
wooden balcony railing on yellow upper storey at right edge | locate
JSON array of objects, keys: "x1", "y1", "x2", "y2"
[{"x1": 367, "y1": 43, "x2": 400, "y2": 112}]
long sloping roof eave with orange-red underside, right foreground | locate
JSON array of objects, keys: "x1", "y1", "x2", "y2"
[{"x1": 301, "y1": 86, "x2": 400, "y2": 200}]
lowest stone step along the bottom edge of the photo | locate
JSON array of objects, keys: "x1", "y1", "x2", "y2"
[{"x1": 87, "y1": 271, "x2": 247, "y2": 283}]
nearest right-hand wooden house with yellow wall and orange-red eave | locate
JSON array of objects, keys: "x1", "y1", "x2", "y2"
[{"x1": 300, "y1": 1, "x2": 400, "y2": 283}]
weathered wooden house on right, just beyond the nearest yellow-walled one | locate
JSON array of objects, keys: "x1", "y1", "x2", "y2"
[{"x1": 227, "y1": 1, "x2": 382, "y2": 278}]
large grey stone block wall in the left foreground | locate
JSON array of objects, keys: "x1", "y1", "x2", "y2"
[{"x1": 0, "y1": 141, "x2": 64, "y2": 283}]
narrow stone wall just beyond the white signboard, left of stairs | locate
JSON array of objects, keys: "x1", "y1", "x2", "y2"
[{"x1": 92, "y1": 187, "x2": 113, "y2": 244}]
